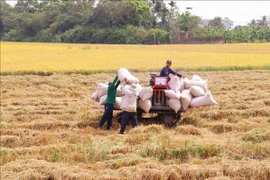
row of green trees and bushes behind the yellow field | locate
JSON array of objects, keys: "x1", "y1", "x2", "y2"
[{"x1": 0, "y1": 0, "x2": 270, "y2": 44}]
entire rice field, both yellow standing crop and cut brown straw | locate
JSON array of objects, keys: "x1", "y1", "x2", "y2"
[{"x1": 0, "y1": 42, "x2": 270, "y2": 180}]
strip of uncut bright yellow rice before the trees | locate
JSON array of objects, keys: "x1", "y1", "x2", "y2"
[{"x1": 1, "y1": 42, "x2": 270, "y2": 74}]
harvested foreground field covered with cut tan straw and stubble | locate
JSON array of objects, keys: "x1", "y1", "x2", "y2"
[{"x1": 0, "y1": 71, "x2": 270, "y2": 180}]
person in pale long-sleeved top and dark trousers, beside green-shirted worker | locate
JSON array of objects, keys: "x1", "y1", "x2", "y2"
[{"x1": 119, "y1": 83, "x2": 139, "y2": 134}]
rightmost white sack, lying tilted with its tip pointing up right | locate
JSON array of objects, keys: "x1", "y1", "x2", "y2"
[{"x1": 190, "y1": 91, "x2": 218, "y2": 107}]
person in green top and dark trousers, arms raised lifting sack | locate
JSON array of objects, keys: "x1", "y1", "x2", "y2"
[{"x1": 98, "y1": 76, "x2": 120, "y2": 130}]
